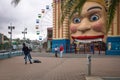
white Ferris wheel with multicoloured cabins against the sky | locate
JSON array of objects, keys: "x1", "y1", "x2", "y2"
[{"x1": 35, "y1": 5, "x2": 53, "y2": 40}]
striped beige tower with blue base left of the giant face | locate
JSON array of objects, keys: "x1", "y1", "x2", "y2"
[{"x1": 52, "y1": 0, "x2": 70, "y2": 53}]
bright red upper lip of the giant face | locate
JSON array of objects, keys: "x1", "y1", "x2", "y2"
[{"x1": 72, "y1": 35, "x2": 104, "y2": 40}]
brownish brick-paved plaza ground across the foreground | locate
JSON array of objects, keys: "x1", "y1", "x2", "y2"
[{"x1": 0, "y1": 52, "x2": 120, "y2": 80}]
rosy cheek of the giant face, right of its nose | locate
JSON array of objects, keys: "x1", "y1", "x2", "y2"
[{"x1": 92, "y1": 21, "x2": 105, "y2": 32}]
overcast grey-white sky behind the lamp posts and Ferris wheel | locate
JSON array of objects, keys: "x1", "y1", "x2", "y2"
[{"x1": 0, "y1": 0, "x2": 52, "y2": 40}]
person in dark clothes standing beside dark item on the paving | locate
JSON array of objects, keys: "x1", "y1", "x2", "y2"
[{"x1": 22, "y1": 43, "x2": 32, "y2": 64}]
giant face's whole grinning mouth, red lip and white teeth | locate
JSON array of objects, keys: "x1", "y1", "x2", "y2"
[{"x1": 72, "y1": 35, "x2": 104, "y2": 43}]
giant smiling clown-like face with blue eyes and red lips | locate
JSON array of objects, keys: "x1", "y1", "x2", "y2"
[{"x1": 70, "y1": 2, "x2": 106, "y2": 42}]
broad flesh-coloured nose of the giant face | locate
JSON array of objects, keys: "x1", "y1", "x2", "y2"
[{"x1": 77, "y1": 19, "x2": 91, "y2": 33}]
